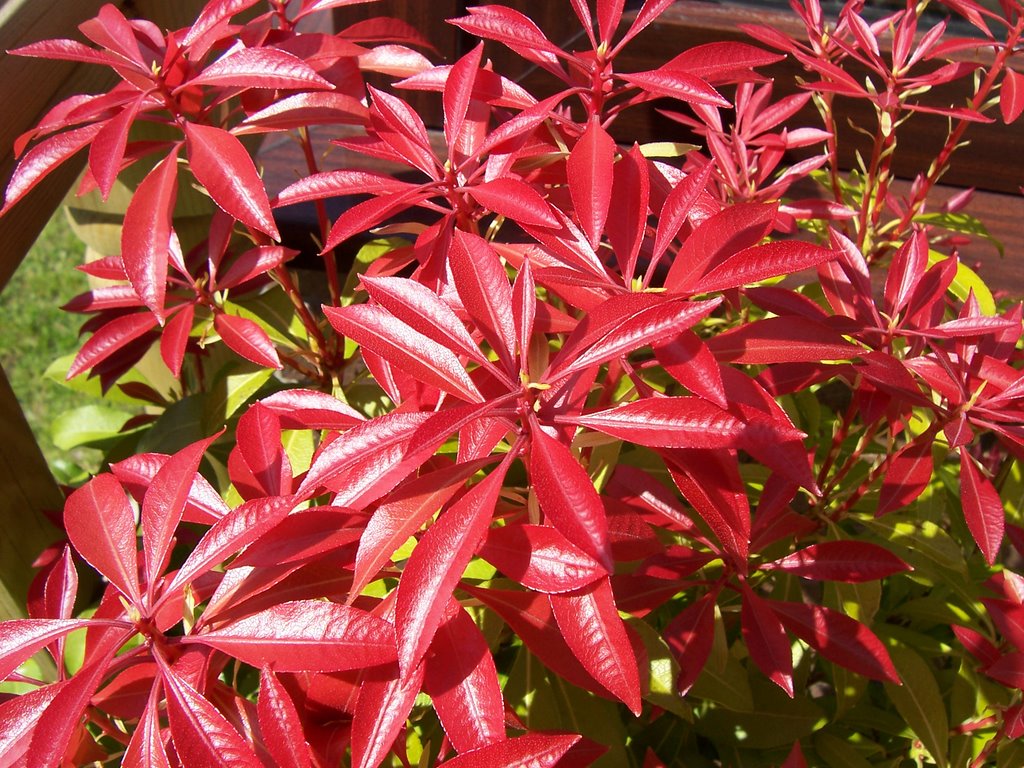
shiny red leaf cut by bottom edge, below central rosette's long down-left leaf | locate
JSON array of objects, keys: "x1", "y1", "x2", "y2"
[{"x1": 352, "y1": 665, "x2": 423, "y2": 768}]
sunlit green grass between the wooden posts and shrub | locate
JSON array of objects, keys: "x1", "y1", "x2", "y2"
[{"x1": 0, "y1": 210, "x2": 93, "y2": 474}]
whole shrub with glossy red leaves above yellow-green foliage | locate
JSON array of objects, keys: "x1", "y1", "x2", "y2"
[{"x1": 0, "y1": 0, "x2": 1024, "y2": 768}]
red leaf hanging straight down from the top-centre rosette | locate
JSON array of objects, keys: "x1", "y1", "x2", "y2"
[{"x1": 565, "y1": 115, "x2": 615, "y2": 248}]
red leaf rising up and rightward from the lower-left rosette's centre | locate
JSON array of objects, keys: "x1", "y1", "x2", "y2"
[{"x1": 140, "y1": 435, "x2": 219, "y2": 599}]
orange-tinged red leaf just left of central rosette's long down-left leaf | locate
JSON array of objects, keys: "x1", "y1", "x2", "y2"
[{"x1": 350, "y1": 461, "x2": 487, "y2": 600}]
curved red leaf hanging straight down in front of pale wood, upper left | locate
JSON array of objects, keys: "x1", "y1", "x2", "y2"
[{"x1": 121, "y1": 144, "x2": 178, "y2": 319}]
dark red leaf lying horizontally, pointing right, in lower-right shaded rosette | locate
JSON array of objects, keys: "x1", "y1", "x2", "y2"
[{"x1": 761, "y1": 541, "x2": 911, "y2": 584}]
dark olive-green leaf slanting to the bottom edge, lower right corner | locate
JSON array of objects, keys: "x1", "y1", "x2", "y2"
[{"x1": 884, "y1": 644, "x2": 949, "y2": 768}]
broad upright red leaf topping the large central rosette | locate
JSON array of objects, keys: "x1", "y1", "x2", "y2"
[{"x1": 449, "y1": 229, "x2": 516, "y2": 371}]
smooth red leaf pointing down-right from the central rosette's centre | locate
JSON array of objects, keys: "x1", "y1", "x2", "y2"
[{"x1": 529, "y1": 428, "x2": 613, "y2": 571}]
